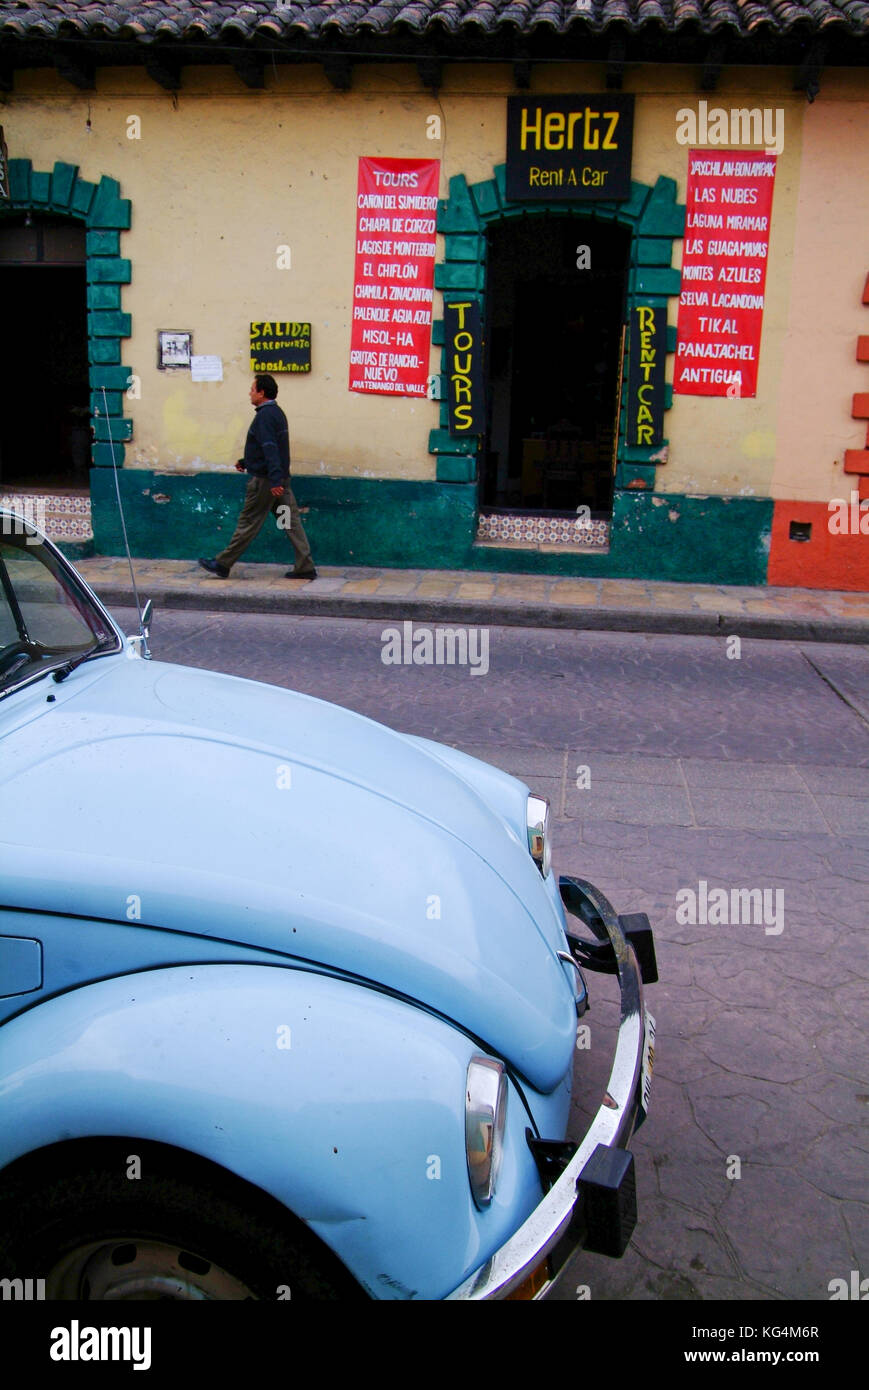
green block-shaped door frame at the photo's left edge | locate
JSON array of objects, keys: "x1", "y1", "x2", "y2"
[{"x1": 0, "y1": 160, "x2": 132, "y2": 467}]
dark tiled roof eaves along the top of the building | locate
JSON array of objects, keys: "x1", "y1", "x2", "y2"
[{"x1": 0, "y1": 0, "x2": 869, "y2": 85}]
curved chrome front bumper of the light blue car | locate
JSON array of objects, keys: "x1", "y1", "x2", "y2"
[{"x1": 446, "y1": 878, "x2": 656, "y2": 1300}]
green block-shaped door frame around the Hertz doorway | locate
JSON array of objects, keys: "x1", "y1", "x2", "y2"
[{"x1": 428, "y1": 164, "x2": 685, "y2": 491}]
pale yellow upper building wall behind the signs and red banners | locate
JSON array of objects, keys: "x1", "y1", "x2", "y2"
[{"x1": 0, "y1": 64, "x2": 869, "y2": 496}]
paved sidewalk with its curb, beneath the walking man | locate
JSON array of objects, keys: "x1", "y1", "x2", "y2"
[{"x1": 76, "y1": 556, "x2": 869, "y2": 642}]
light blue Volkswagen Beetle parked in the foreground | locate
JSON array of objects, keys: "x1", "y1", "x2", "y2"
[{"x1": 0, "y1": 513, "x2": 656, "y2": 1300}]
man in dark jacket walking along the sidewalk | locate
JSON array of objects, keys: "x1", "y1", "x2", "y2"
[{"x1": 199, "y1": 373, "x2": 317, "y2": 580}]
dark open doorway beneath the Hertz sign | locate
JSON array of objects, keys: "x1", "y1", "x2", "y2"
[{"x1": 481, "y1": 214, "x2": 630, "y2": 516}]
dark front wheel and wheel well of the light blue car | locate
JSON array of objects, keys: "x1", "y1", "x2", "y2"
[{"x1": 0, "y1": 1143, "x2": 362, "y2": 1301}]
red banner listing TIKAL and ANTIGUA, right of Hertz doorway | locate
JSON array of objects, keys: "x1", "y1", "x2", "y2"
[{"x1": 673, "y1": 150, "x2": 776, "y2": 396}]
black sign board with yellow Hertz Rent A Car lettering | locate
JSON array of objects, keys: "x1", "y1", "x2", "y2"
[{"x1": 506, "y1": 92, "x2": 634, "y2": 203}]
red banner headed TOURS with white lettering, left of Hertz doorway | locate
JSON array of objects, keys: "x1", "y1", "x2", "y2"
[{"x1": 350, "y1": 158, "x2": 439, "y2": 396}]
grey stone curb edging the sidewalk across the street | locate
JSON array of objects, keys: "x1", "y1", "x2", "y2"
[{"x1": 81, "y1": 575, "x2": 869, "y2": 644}]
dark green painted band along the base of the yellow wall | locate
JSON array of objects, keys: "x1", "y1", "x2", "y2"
[{"x1": 92, "y1": 472, "x2": 773, "y2": 585}]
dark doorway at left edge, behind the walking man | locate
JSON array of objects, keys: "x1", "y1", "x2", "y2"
[{"x1": 0, "y1": 214, "x2": 90, "y2": 489}]
